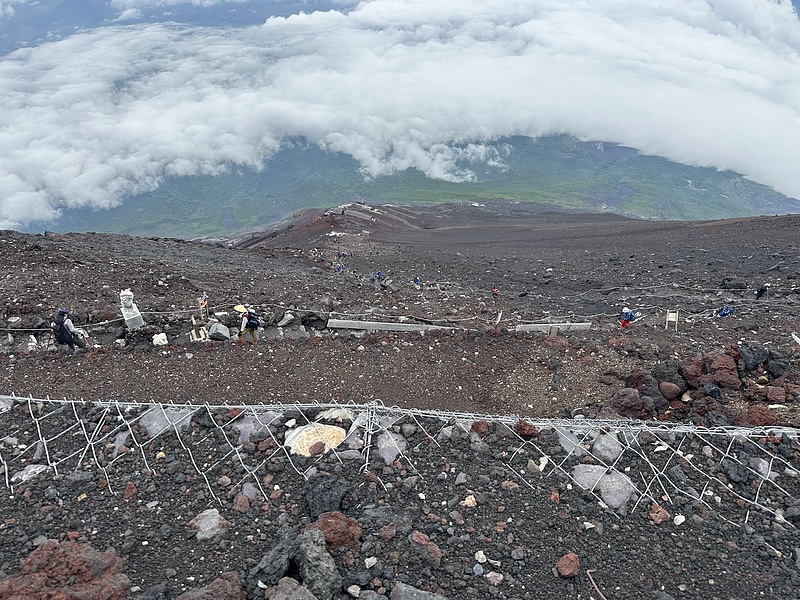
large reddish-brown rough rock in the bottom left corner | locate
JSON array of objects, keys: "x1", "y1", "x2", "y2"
[{"x1": 0, "y1": 540, "x2": 131, "y2": 600}]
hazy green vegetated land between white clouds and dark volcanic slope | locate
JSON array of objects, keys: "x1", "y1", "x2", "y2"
[{"x1": 51, "y1": 136, "x2": 800, "y2": 238}]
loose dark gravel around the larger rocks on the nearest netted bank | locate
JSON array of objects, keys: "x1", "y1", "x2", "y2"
[{"x1": 0, "y1": 402, "x2": 800, "y2": 599}]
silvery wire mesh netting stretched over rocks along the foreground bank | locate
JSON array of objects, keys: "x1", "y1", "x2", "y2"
[{"x1": 0, "y1": 396, "x2": 800, "y2": 527}]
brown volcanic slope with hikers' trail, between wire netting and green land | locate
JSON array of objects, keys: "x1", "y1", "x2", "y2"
[{"x1": 0, "y1": 202, "x2": 800, "y2": 421}]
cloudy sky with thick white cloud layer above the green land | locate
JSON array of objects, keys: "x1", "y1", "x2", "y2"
[{"x1": 0, "y1": 0, "x2": 800, "y2": 229}]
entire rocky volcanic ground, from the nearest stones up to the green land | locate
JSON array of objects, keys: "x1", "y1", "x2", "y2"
[{"x1": 0, "y1": 203, "x2": 800, "y2": 600}]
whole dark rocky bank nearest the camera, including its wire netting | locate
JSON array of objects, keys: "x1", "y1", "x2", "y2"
[{"x1": 0, "y1": 399, "x2": 800, "y2": 600}]
